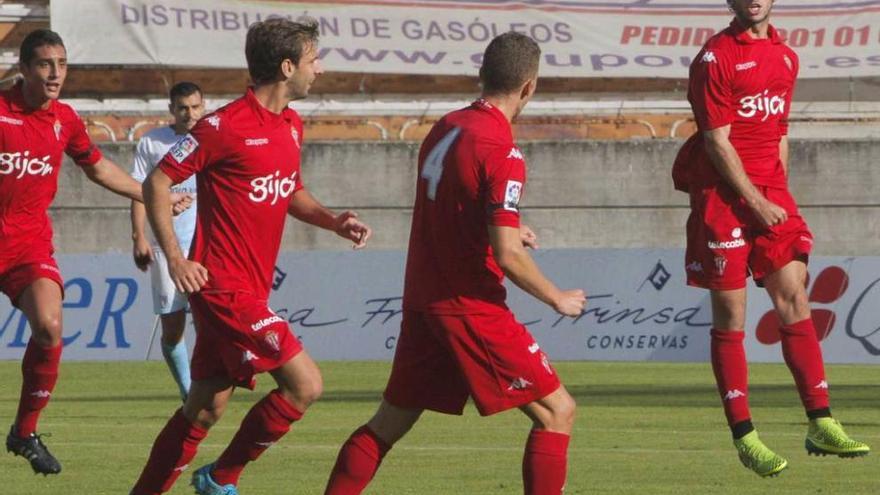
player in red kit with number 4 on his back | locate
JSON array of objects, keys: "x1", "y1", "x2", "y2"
[{"x1": 325, "y1": 32, "x2": 586, "y2": 495}]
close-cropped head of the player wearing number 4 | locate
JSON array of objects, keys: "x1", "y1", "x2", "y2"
[{"x1": 480, "y1": 31, "x2": 541, "y2": 95}]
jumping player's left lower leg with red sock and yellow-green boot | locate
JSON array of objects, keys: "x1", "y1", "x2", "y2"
[{"x1": 710, "y1": 288, "x2": 788, "y2": 476}]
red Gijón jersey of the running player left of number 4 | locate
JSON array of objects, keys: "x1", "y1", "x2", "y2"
[{"x1": 158, "y1": 90, "x2": 303, "y2": 299}]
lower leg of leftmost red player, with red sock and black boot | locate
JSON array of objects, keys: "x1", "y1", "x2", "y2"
[{"x1": 6, "y1": 278, "x2": 63, "y2": 475}]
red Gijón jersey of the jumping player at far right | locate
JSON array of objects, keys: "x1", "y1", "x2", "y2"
[{"x1": 679, "y1": 20, "x2": 798, "y2": 187}]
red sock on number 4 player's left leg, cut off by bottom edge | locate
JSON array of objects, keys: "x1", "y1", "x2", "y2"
[{"x1": 324, "y1": 425, "x2": 391, "y2": 495}]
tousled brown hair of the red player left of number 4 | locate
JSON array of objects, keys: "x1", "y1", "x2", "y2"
[{"x1": 244, "y1": 17, "x2": 319, "y2": 84}]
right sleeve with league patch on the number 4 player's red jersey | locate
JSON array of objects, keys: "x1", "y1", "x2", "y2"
[{"x1": 483, "y1": 146, "x2": 526, "y2": 228}]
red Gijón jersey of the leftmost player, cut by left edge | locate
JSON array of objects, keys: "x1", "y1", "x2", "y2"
[{"x1": 0, "y1": 83, "x2": 102, "y2": 261}]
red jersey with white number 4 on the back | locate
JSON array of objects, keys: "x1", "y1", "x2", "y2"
[{"x1": 403, "y1": 100, "x2": 526, "y2": 314}]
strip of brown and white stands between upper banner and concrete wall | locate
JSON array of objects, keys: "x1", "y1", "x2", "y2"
[{"x1": 0, "y1": 0, "x2": 880, "y2": 141}]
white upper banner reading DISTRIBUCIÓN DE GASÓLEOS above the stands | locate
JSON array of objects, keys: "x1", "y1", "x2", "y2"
[{"x1": 51, "y1": 0, "x2": 880, "y2": 78}]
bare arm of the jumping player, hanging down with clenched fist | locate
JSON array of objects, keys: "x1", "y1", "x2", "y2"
[{"x1": 703, "y1": 125, "x2": 788, "y2": 230}]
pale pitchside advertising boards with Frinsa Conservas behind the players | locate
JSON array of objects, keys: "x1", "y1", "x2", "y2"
[{"x1": 0, "y1": 249, "x2": 880, "y2": 364}]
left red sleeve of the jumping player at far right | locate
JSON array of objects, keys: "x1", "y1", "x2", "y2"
[{"x1": 688, "y1": 49, "x2": 736, "y2": 132}]
